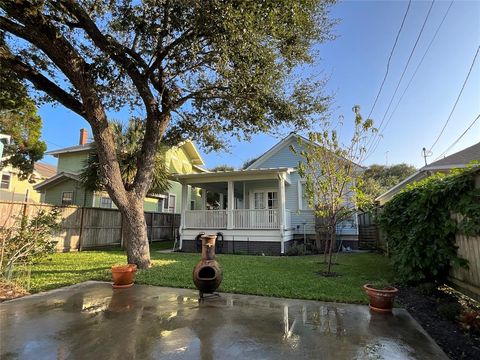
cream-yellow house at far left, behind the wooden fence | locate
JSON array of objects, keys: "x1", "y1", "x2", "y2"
[{"x1": 0, "y1": 163, "x2": 56, "y2": 202}]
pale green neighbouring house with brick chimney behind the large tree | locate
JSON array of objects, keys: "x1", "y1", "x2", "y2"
[{"x1": 35, "y1": 129, "x2": 206, "y2": 213}]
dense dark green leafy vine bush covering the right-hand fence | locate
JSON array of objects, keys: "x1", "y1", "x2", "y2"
[{"x1": 379, "y1": 168, "x2": 480, "y2": 284}]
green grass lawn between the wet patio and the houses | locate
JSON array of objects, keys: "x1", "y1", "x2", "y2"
[{"x1": 30, "y1": 244, "x2": 392, "y2": 303}]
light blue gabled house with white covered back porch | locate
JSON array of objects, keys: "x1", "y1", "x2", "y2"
[{"x1": 174, "y1": 133, "x2": 358, "y2": 255}]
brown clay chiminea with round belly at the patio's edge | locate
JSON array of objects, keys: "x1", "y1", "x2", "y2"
[{"x1": 193, "y1": 235, "x2": 223, "y2": 299}]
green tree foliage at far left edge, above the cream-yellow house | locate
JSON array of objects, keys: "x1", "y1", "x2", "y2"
[{"x1": 0, "y1": 47, "x2": 47, "y2": 179}]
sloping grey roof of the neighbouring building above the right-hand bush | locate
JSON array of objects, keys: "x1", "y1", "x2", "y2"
[{"x1": 375, "y1": 142, "x2": 480, "y2": 205}]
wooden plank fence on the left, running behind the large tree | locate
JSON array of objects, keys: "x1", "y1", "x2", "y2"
[{"x1": 0, "y1": 202, "x2": 180, "y2": 251}]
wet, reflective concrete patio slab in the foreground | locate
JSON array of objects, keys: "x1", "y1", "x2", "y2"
[{"x1": 0, "y1": 282, "x2": 447, "y2": 360}]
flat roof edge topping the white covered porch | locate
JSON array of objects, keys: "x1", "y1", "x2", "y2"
[{"x1": 172, "y1": 167, "x2": 296, "y2": 184}]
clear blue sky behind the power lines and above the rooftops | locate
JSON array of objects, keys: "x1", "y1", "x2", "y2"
[{"x1": 40, "y1": 0, "x2": 480, "y2": 167}]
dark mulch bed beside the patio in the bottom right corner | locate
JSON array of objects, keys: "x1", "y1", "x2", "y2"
[{"x1": 397, "y1": 287, "x2": 480, "y2": 359}]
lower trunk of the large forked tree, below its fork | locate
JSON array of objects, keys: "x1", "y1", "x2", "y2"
[{"x1": 120, "y1": 198, "x2": 150, "y2": 269}]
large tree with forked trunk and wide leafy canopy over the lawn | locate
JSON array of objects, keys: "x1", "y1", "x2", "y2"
[{"x1": 0, "y1": 0, "x2": 334, "y2": 268}]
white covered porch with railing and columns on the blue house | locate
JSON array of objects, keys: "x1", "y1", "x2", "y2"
[{"x1": 175, "y1": 168, "x2": 294, "y2": 254}]
